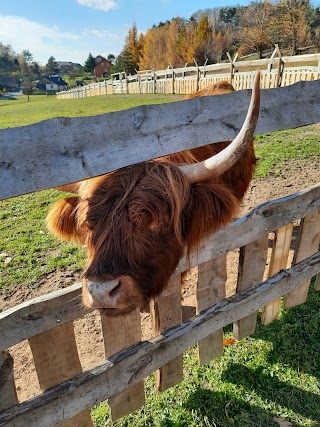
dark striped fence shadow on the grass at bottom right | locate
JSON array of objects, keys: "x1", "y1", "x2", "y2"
[{"x1": 185, "y1": 285, "x2": 320, "y2": 427}]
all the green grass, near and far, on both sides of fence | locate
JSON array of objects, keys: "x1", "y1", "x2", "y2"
[{"x1": 0, "y1": 96, "x2": 320, "y2": 427}]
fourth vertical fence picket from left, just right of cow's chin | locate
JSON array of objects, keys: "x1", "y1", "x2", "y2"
[{"x1": 150, "y1": 274, "x2": 183, "y2": 391}]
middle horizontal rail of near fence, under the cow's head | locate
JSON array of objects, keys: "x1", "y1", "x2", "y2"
[{"x1": 0, "y1": 184, "x2": 320, "y2": 350}]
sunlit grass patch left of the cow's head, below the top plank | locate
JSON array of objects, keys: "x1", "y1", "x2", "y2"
[{"x1": 0, "y1": 190, "x2": 85, "y2": 292}]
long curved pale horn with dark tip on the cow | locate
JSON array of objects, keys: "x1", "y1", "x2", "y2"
[{"x1": 179, "y1": 70, "x2": 260, "y2": 183}]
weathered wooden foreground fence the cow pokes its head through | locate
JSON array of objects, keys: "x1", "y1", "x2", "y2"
[{"x1": 0, "y1": 81, "x2": 320, "y2": 426}]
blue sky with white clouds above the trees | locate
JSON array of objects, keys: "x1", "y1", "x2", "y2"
[{"x1": 0, "y1": 0, "x2": 254, "y2": 65}]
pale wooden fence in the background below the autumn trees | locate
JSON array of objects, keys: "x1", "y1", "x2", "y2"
[{"x1": 57, "y1": 48, "x2": 320, "y2": 99}]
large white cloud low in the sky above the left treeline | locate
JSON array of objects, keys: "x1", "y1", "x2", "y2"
[{"x1": 0, "y1": 14, "x2": 125, "y2": 65}]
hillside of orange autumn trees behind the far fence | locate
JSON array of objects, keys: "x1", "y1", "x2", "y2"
[{"x1": 111, "y1": 0, "x2": 320, "y2": 74}]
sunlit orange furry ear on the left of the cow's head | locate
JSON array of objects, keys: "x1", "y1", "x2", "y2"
[{"x1": 46, "y1": 197, "x2": 83, "y2": 243}]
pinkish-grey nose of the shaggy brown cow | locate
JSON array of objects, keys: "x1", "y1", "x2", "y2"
[{"x1": 87, "y1": 279, "x2": 121, "y2": 308}]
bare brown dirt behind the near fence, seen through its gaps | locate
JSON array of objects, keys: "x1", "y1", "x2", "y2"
[{"x1": 0, "y1": 156, "x2": 320, "y2": 401}]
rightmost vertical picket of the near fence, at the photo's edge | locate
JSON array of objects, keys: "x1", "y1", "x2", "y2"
[{"x1": 284, "y1": 210, "x2": 320, "y2": 308}]
